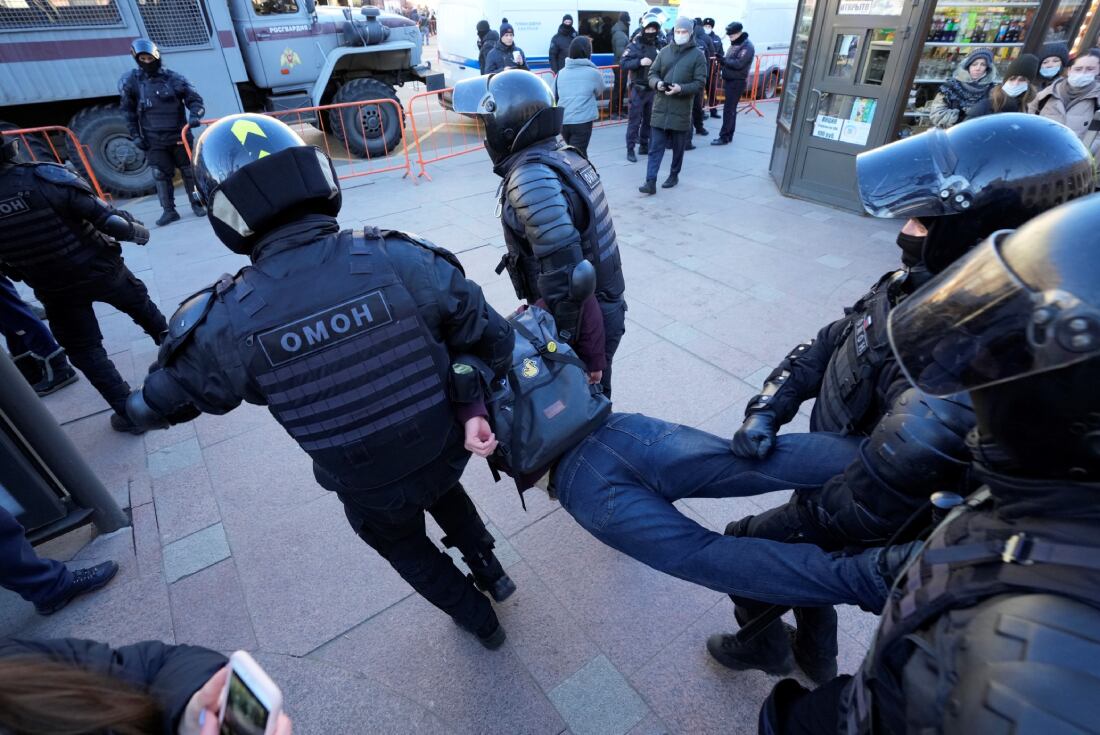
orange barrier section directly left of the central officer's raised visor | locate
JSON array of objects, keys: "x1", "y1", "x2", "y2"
[{"x1": 406, "y1": 87, "x2": 485, "y2": 182}]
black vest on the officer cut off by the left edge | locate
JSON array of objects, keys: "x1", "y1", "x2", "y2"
[{"x1": 0, "y1": 164, "x2": 106, "y2": 290}]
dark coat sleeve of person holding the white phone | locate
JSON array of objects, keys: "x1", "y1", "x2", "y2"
[{"x1": 0, "y1": 638, "x2": 227, "y2": 735}]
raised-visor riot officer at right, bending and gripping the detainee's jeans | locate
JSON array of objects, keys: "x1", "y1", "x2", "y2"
[{"x1": 707, "y1": 114, "x2": 1092, "y2": 682}]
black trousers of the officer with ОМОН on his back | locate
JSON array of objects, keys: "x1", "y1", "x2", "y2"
[{"x1": 330, "y1": 451, "x2": 496, "y2": 632}]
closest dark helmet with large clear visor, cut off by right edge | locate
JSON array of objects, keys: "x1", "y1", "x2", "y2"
[{"x1": 889, "y1": 195, "x2": 1100, "y2": 481}]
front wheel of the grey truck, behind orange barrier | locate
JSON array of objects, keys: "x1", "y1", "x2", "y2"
[{"x1": 329, "y1": 78, "x2": 405, "y2": 158}]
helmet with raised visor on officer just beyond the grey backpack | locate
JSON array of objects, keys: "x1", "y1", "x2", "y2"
[{"x1": 454, "y1": 69, "x2": 565, "y2": 163}]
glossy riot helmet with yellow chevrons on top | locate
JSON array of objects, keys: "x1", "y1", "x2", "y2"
[{"x1": 195, "y1": 114, "x2": 341, "y2": 255}]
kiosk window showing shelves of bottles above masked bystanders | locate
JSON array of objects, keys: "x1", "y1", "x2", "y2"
[{"x1": 897, "y1": 0, "x2": 1038, "y2": 138}]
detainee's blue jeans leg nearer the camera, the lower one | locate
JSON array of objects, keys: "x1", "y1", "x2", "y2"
[{"x1": 553, "y1": 438, "x2": 887, "y2": 610}]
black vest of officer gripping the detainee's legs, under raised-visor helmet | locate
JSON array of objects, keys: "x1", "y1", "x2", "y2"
[{"x1": 811, "y1": 273, "x2": 898, "y2": 435}]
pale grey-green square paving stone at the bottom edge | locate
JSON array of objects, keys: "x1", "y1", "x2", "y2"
[{"x1": 550, "y1": 656, "x2": 649, "y2": 735}]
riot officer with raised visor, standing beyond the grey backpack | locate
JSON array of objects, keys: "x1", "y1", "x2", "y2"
[{"x1": 454, "y1": 70, "x2": 626, "y2": 397}]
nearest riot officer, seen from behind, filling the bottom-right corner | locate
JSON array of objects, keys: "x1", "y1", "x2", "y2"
[{"x1": 760, "y1": 196, "x2": 1100, "y2": 735}]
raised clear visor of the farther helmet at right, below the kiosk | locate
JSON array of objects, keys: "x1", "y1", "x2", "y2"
[{"x1": 856, "y1": 129, "x2": 958, "y2": 217}]
